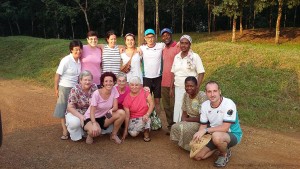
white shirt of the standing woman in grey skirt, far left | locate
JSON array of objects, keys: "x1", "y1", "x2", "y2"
[{"x1": 56, "y1": 53, "x2": 81, "y2": 87}]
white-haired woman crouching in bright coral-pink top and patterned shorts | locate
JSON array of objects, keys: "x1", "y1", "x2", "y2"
[{"x1": 122, "y1": 76, "x2": 154, "y2": 142}]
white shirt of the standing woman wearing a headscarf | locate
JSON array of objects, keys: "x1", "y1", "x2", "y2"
[{"x1": 171, "y1": 51, "x2": 205, "y2": 87}]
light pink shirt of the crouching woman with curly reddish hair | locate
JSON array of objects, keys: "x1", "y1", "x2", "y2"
[{"x1": 84, "y1": 87, "x2": 119, "y2": 119}]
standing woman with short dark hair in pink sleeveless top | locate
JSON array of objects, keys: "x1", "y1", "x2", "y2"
[{"x1": 81, "y1": 31, "x2": 102, "y2": 88}]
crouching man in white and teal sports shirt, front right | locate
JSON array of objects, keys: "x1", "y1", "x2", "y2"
[{"x1": 193, "y1": 81, "x2": 243, "y2": 167}]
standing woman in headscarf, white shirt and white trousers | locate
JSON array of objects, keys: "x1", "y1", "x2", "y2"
[{"x1": 170, "y1": 35, "x2": 205, "y2": 123}]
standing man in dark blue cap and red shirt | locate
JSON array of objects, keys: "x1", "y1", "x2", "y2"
[{"x1": 160, "y1": 28, "x2": 180, "y2": 134}]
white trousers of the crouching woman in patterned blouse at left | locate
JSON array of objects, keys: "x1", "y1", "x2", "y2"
[{"x1": 66, "y1": 113, "x2": 84, "y2": 141}]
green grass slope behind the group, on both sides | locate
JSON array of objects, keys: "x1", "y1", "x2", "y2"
[{"x1": 0, "y1": 34, "x2": 300, "y2": 132}]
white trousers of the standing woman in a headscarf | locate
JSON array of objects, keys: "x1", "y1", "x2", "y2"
[{"x1": 173, "y1": 86, "x2": 185, "y2": 123}]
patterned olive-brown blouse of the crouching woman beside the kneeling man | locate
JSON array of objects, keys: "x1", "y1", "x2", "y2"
[{"x1": 181, "y1": 91, "x2": 208, "y2": 117}]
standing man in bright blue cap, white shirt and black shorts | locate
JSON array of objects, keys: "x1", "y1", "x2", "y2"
[{"x1": 140, "y1": 29, "x2": 165, "y2": 121}]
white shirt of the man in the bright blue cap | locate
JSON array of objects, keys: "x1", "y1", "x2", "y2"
[{"x1": 140, "y1": 43, "x2": 165, "y2": 78}]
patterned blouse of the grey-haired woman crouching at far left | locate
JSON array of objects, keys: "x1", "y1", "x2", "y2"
[{"x1": 68, "y1": 83, "x2": 98, "y2": 114}]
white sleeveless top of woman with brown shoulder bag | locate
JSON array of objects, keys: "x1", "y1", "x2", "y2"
[{"x1": 121, "y1": 52, "x2": 143, "y2": 83}]
